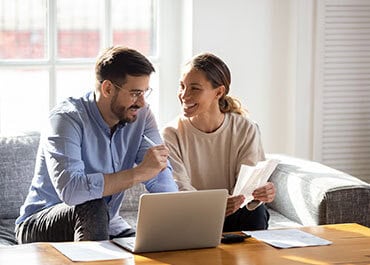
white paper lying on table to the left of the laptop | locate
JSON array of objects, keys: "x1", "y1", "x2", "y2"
[{"x1": 51, "y1": 241, "x2": 135, "y2": 264}]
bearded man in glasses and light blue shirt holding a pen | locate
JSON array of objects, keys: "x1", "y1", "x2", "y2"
[{"x1": 15, "y1": 46, "x2": 178, "y2": 243}]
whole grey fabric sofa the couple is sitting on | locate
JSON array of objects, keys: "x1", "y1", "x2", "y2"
[{"x1": 0, "y1": 132, "x2": 370, "y2": 247}]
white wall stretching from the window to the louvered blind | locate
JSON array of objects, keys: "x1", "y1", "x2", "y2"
[{"x1": 161, "y1": 0, "x2": 314, "y2": 159}]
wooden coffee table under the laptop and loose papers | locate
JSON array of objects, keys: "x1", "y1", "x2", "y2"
[{"x1": 0, "y1": 224, "x2": 370, "y2": 265}]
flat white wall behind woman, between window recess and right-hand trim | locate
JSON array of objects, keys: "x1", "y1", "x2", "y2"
[{"x1": 189, "y1": 0, "x2": 295, "y2": 153}]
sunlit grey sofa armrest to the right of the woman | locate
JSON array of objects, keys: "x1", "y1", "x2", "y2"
[{"x1": 267, "y1": 154, "x2": 370, "y2": 227}]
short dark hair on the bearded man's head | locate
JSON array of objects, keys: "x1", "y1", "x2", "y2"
[{"x1": 95, "y1": 46, "x2": 155, "y2": 85}]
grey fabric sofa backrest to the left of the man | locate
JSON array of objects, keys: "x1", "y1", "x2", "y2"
[{"x1": 0, "y1": 132, "x2": 40, "y2": 219}]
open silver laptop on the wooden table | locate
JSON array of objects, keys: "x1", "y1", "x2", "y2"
[{"x1": 112, "y1": 189, "x2": 228, "y2": 253}]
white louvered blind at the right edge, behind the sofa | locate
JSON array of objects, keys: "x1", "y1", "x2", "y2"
[{"x1": 314, "y1": 0, "x2": 370, "y2": 183}]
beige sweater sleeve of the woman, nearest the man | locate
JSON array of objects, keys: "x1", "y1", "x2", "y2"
[{"x1": 162, "y1": 127, "x2": 196, "y2": 191}]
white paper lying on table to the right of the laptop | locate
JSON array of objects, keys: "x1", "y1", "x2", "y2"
[{"x1": 243, "y1": 229, "x2": 332, "y2": 248}]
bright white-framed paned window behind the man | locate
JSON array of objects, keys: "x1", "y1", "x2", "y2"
[{"x1": 0, "y1": 0, "x2": 159, "y2": 133}]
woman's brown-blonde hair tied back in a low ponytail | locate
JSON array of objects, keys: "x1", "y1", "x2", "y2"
[{"x1": 188, "y1": 53, "x2": 247, "y2": 115}]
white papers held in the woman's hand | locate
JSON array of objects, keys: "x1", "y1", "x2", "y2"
[{"x1": 233, "y1": 159, "x2": 279, "y2": 208}]
